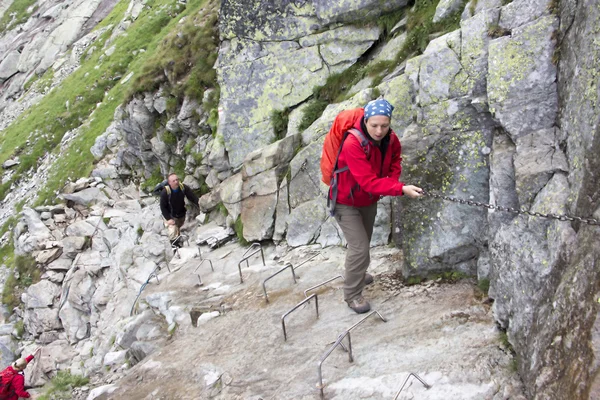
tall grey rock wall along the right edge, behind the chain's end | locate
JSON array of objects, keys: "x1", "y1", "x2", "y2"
[{"x1": 490, "y1": 1, "x2": 600, "y2": 399}]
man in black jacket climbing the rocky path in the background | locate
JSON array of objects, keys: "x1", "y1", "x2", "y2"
[{"x1": 160, "y1": 174, "x2": 198, "y2": 244}]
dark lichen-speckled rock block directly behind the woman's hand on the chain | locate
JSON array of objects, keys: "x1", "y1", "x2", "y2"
[{"x1": 396, "y1": 98, "x2": 494, "y2": 276}]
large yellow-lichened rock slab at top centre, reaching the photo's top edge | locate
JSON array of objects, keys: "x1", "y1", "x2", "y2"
[{"x1": 217, "y1": 0, "x2": 398, "y2": 167}]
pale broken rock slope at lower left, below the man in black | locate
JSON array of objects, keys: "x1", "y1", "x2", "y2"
[{"x1": 8, "y1": 186, "x2": 176, "y2": 385}]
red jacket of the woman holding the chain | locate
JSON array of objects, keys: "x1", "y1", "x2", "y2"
[{"x1": 330, "y1": 118, "x2": 404, "y2": 207}]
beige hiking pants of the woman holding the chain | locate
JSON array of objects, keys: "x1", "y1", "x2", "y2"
[{"x1": 335, "y1": 203, "x2": 377, "y2": 301}]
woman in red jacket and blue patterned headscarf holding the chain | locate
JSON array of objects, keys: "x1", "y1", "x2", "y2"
[{"x1": 329, "y1": 99, "x2": 423, "y2": 314}]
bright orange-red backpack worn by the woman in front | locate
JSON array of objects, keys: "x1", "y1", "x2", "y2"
[{"x1": 321, "y1": 108, "x2": 368, "y2": 186}]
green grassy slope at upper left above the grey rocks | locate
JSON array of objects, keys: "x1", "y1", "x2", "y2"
[{"x1": 0, "y1": 0, "x2": 217, "y2": 204}]
